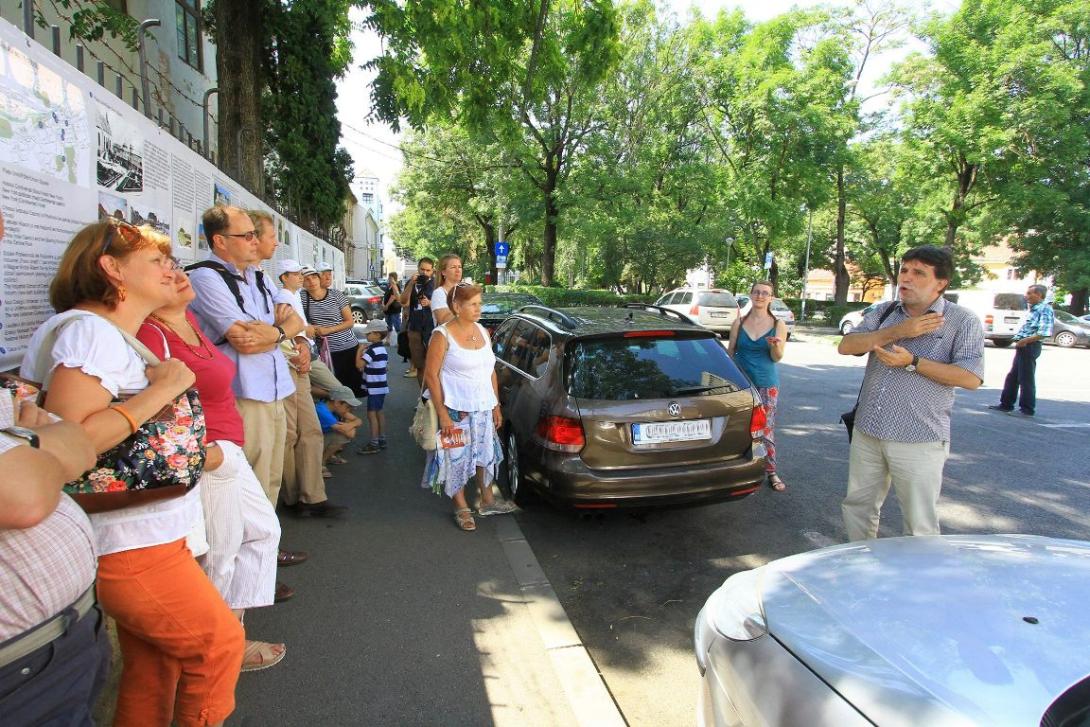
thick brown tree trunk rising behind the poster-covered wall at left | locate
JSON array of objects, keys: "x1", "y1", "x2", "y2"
[{"x1": 215, "y1": 0, "x2": 265, "y2": 197}]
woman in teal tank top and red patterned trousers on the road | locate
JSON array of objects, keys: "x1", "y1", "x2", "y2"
[{"x1": 727, "y1": 280, "x2": 787, "y2": 492}]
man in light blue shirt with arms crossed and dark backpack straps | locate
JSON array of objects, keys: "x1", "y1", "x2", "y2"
[{"x1": 189, "y1": 205, "x2": 303, "y2": 507}]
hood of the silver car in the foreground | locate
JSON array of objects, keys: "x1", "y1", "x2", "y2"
[{"x1": 762, "y1": 535, "x2": 1090, "y2": 727}]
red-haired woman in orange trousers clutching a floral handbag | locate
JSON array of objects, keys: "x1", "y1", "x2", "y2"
[{"x1": 21, "y1": 220, "x2": 243, "y2": 727}]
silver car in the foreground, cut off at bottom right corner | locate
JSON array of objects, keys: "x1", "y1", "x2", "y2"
[{"x1": 695, "y1": 535, "x2": 1090, "y2": 727}]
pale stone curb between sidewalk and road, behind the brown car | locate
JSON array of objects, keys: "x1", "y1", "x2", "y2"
[{"x1": 496, "y1": 518, "x2": 628, "y2": 727}]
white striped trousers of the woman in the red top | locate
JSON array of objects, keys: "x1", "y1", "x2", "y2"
[{"x1": 198, "y1": 441, "x2": 280, "y2": 608}]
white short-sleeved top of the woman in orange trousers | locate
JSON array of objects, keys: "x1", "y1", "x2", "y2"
[{"x1": 20, "y1": 311, "x2": 202, "y2": 556}]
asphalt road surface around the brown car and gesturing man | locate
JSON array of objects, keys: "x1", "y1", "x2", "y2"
[{"x1": 518, "y1": 334, "x2": 1090, "y2": 726}]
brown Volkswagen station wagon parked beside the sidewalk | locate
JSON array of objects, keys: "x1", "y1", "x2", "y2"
[{"x1": 494, "y1": 305, "x2": 764, "y2": 508}]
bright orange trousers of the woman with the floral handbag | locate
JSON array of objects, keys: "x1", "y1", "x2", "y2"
[{"x1": 98, "y1": 538, "x2": 245, "y2": 727}]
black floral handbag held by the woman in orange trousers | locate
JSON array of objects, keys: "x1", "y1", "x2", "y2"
[{"x1": 38, "y1": 314, "x2": 205, "y2": 512}]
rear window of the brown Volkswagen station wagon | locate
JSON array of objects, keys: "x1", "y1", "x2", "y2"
[{"x1": 567, "y1": 336, "x2": 749, "y2": 401}]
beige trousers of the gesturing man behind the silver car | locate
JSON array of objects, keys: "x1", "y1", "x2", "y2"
[{"x1": 840, "y1": 428, "x2": 950, "y2": 541}]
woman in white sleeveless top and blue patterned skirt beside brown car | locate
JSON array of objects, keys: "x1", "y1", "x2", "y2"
[{"x1": 423, "y1": 283, "x2": 514, "y2": 531}]
